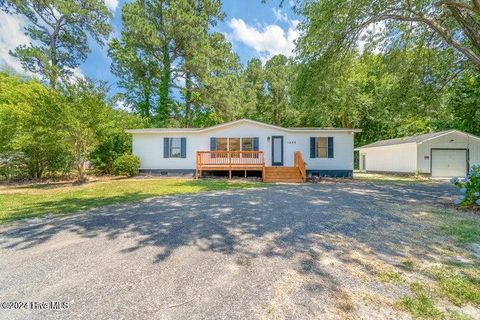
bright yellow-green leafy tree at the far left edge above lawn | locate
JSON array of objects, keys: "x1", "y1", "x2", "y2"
[{"x1": 0, "y1": 72, "x2": 71, "y2": 178}]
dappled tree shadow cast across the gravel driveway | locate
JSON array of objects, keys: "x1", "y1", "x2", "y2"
[{"x1": 0, "y1": 182, "x2": 452, "y2": 262}]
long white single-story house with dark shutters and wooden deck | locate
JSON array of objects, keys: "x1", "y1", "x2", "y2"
[{"x1": 126, "y1": 119, "x2": 361, "y2": 182}]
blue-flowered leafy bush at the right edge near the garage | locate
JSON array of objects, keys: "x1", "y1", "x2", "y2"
[{"x1": 451, "y1": 166, "x2": 480, "y2": 206}]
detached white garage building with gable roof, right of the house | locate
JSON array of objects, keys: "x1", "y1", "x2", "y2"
[{"x1": 355, "y1": 130, "x2": 480, "y2": 178}]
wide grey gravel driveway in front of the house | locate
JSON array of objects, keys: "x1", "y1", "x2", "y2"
[{"x1": 0, "y1": 181, "x2": 466, "y2": 319}]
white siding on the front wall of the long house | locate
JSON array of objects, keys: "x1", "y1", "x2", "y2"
[{"x1": 133, "y1": 123, "x2": 354, "y2": 170}]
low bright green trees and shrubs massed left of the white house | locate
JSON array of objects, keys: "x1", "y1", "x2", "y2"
[{"x1": 0, "y1": 72, "x2": 145, "y2": 181}]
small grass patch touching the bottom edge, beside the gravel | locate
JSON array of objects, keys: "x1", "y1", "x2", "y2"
[{"x1": 399, "y1": 282, "x2": 444, "y2": 319}]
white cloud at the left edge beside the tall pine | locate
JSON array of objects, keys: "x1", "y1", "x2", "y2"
[{"x1": 0, "y1": 11, "x2": 30, "y2": 73}]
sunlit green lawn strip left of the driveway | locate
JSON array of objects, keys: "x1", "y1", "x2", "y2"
[{"x1": 0, "y1": 179, "x2": 260, "y2": 223}]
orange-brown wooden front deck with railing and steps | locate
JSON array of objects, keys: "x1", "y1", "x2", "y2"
[{"x1": 195, "y1": 151, "x2": 307, "y2": 182}]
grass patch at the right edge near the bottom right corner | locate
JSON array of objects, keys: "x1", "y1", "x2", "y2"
[{"x1": 430, "y1": 267, "x2": 480, "y2": 306}]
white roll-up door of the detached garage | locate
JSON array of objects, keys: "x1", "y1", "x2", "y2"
[{"x1": 432, "y1": 149, "x2": 467, "y2": 178}]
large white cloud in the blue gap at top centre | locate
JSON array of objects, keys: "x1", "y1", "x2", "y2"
[{"x1": 228, "y1": 18, "x2": 300, "y2": 58}]
